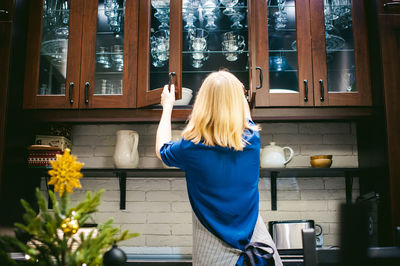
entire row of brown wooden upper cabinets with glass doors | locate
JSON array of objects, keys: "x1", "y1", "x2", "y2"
[{"x1": 24, "y1": 0, "x2": 372, "y2": 109}]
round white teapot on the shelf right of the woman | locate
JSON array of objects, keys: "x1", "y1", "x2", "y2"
[{"x1": 260, "y1": 142, "x2": 294, "y2": 168}]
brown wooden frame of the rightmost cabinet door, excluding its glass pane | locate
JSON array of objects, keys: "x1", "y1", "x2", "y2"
[{"x1": 310, "y1": 0, "x2": 372, "y2": 106}]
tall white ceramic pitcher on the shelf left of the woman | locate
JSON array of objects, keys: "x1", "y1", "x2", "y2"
[{"x1": 114, "y1": 130, "x2": 139, "y2": 168}]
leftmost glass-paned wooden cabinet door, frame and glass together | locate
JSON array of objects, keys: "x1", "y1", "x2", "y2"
[{"x1": 24, "y1": 0, "x2": 82, "y2": 108}]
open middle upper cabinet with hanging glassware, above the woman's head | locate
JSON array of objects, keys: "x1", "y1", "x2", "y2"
[{"x1": 138, "y1": 0, "x2": 255, "y2": 108}]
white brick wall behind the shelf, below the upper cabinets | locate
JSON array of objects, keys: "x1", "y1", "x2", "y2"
[{"x1": 42, "y1": 122, "x2": 359, "y2": 254}]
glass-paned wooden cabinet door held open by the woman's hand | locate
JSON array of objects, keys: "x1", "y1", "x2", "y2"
[{"x1": 137, "y1": 0, "x2": 182, "y2": 107}]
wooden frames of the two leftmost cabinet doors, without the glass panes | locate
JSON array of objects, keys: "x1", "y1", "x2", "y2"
[{"x1": 23, "y1": 0, "x2": 139, "y2": 109}]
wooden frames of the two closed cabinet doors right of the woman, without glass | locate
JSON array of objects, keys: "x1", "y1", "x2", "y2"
[{"x1": 253, "y1": 0, "x2": 372, "y2": 107}]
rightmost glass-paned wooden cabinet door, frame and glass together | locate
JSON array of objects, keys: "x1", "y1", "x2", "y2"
[{"x1": 312, "y1": 0, "x2": 371, "y2": 105}]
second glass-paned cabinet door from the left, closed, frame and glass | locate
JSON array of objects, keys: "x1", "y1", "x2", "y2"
[{"x1": 80, "y1": 0, "x2": 138, "y2": 108}]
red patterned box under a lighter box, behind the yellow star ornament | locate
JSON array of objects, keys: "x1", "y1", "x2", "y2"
[{"x1": 28, "y1": 145, "x2": 63, "y2": 168}]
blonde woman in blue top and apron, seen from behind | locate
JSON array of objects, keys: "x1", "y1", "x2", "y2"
[{"x1": 156, "y1": 71, "x2": 282, "y2": 266}]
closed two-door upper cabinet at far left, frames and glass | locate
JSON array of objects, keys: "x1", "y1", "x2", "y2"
[{"x1": 24, "y1": 0, "x2": 139, "y2": 109}]
